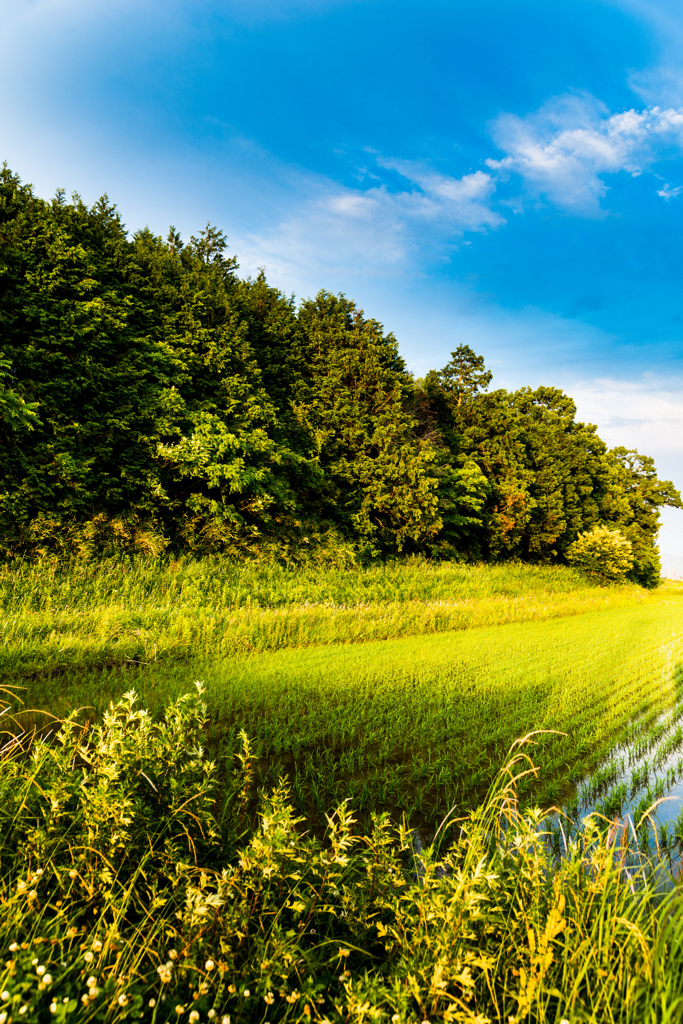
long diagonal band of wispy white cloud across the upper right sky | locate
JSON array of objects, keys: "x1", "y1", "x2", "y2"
[{"x1": 241, "y1": 95, "x2": 683, "y2": 286}]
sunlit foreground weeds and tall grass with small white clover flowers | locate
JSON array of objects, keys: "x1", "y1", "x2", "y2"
[{"x1": 0, "y1": 693, "x2": 683, "y2": 1024}]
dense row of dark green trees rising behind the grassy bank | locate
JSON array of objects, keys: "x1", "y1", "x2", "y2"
[{"x1": 0, "y1": 166, "x2": 681, "y2": 585}]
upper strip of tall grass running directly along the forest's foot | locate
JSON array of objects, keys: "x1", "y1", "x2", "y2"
[{"x1": 0, "y1": 556, "x2": 618, "y2": 611}]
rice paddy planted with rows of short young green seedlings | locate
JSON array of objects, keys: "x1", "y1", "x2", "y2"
[{"x1": 18, "y1": 596, "x2": 683, "y2": 828}]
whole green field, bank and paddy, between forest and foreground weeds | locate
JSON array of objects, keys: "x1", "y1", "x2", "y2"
[{"x1": 0, "y1": 559, "x2": 683, "y2": 838}]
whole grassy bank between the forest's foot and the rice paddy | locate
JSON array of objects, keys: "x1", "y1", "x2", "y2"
[{"x1": 0, "y1": 557, "x2": 647, "y2": 682}]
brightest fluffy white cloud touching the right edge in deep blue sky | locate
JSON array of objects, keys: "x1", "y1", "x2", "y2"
[{"x1": 486, "y1": 96, "x2": 683, "y2": 214}]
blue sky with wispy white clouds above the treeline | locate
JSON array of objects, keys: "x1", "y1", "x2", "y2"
[{"x1": 0, "y1": 0, "x2": 683, "y2": 557}]
